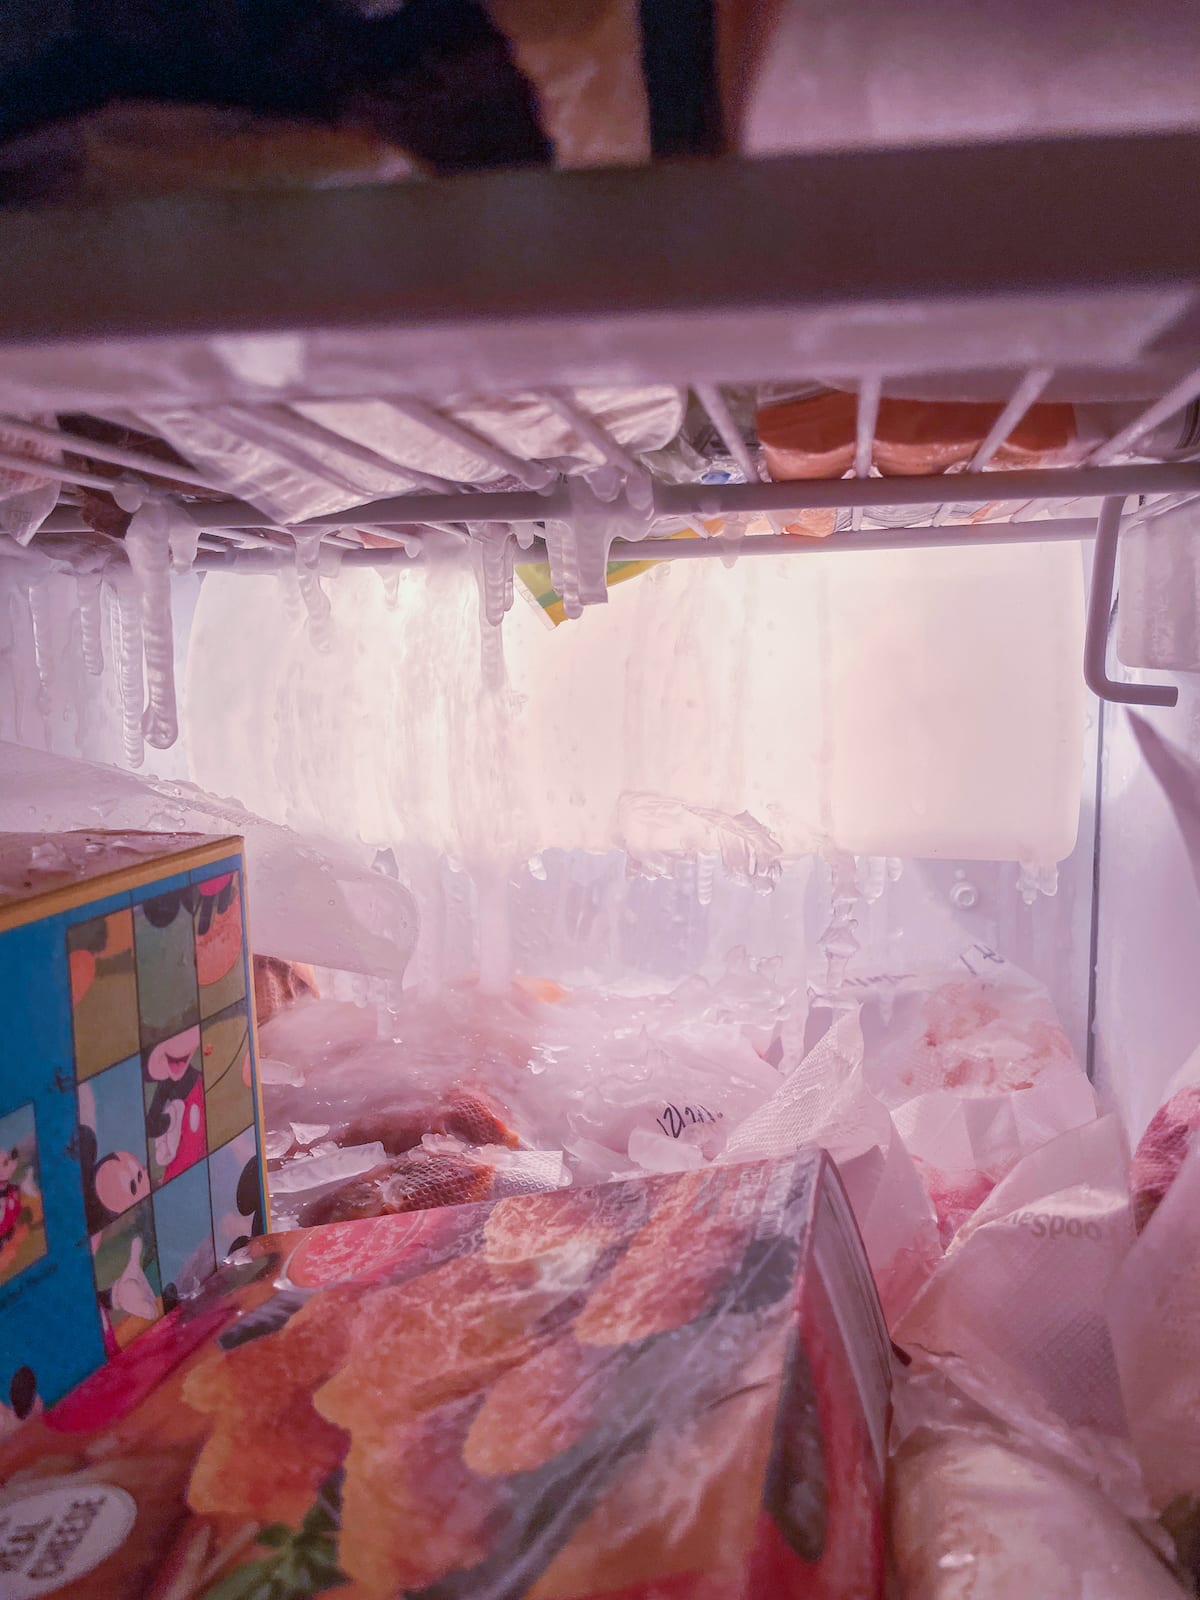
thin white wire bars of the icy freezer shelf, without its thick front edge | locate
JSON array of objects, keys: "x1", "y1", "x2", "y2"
[{"x1": 16, "y1": 377, "x2": 1200, "y2": 706}]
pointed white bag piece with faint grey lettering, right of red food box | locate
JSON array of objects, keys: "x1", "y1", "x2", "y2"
[{"x1": 893, "y1": 1117, "x2": 1133, "y2": 1435}]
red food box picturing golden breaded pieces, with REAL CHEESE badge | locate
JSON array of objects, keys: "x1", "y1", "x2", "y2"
[{"x1": 0, "y1": 1152, "x2": 890, "y2": 1600}]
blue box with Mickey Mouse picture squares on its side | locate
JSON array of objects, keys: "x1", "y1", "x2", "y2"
[{"x1": 0, "y1": 832, "x2": 266, "y2": 1437}]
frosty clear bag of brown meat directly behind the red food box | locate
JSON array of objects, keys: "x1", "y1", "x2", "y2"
[{"x1": 261, "y1": 981, "x2": 797, "y2": 1203}]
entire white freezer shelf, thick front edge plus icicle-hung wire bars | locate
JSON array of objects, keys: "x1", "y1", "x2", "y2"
[{"x1": 0, "y1": 136, "x2": 1200, "y2": 704}]
